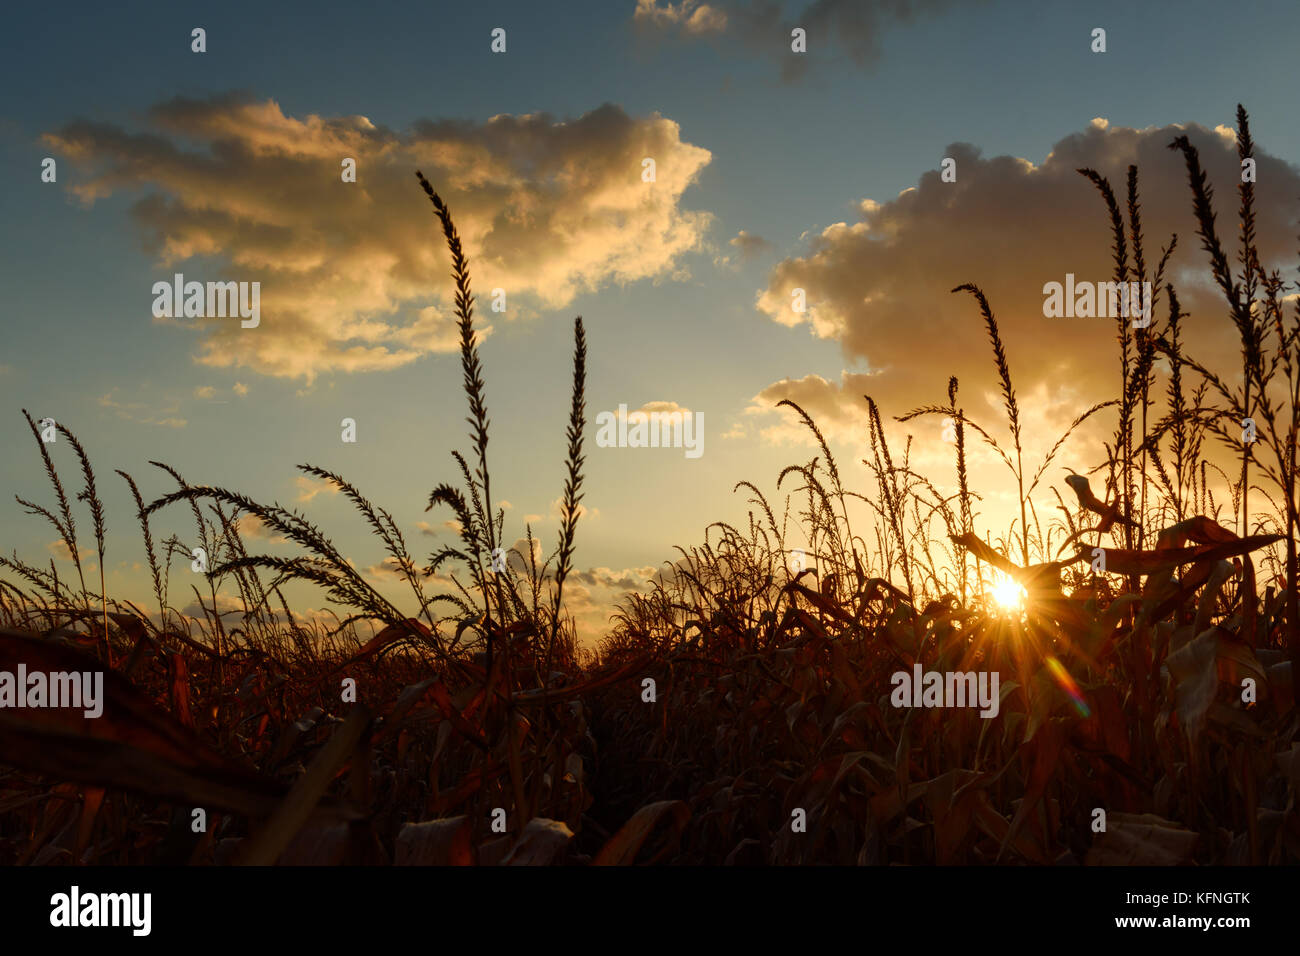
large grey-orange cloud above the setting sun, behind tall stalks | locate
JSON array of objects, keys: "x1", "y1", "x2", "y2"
[{"x1": 754, "y1": 121, "x2": 1300, "y2": 429}]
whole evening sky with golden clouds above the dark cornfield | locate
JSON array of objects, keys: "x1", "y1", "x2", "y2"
[{"x1": 0, "y1": 0, "x2": 1300, "y2": 641}]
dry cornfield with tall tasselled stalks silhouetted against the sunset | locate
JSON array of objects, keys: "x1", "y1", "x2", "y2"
[{"x1": 0, "y1": 108, "x2": 1300, "y2": 865}]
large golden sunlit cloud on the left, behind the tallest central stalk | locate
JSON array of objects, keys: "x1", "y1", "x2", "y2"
[{"x1": 44, "y1": 94, "x2": 710, "y2": 384}]
